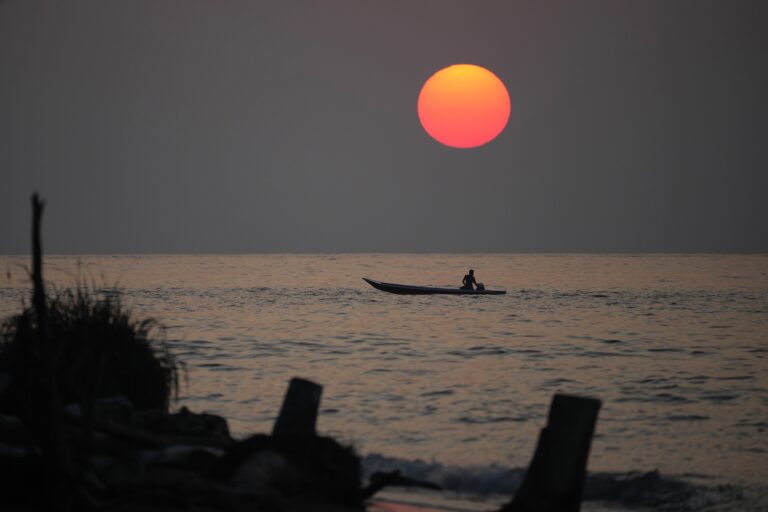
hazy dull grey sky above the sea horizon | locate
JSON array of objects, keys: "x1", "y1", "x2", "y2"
[{"x1": 0, "y1": 0, "x2": 768, "y2": 253}]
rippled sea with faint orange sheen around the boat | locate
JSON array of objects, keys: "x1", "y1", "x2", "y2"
[{"x1": 0, "y1": 254, "x2": 768, "y2": 511}]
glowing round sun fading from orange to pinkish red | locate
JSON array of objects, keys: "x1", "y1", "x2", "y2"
[{"x1": 418, "y1": 64, "x2": 511, "y2": 148}]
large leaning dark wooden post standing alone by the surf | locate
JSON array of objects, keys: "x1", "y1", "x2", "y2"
[{"x1": 502, "y1": 395, "x2": 600, "y2": 512}]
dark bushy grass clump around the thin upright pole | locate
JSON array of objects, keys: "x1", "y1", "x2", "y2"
[{"x1": 0, "y1": 286, "x2": 182, "y2": 415}]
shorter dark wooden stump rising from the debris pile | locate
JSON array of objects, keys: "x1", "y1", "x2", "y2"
[{"x1": 272, "y1": 377, "x2": 323, "y2": 437}]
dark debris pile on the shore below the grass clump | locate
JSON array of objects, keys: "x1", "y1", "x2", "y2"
[{"x1": 0, "y1": 397, "x2": 366, "y2": 511}]
